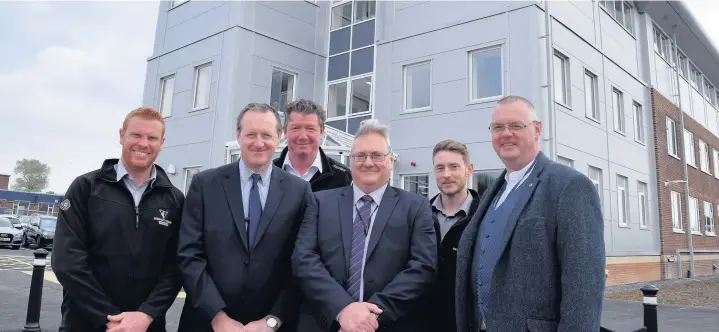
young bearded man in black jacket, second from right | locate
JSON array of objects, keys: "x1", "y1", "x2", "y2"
[{"x1": 428, "y1": 139, "x2": 481, "y2": 331}]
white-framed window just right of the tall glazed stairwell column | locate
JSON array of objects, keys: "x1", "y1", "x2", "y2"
[{"x1": 404, "y1": 62, "x2": 432, "y2": 111}]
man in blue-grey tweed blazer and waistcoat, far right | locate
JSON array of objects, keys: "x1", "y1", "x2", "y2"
[{"x1": 455, "y1": 96, "x2": 605, "y2": 332}]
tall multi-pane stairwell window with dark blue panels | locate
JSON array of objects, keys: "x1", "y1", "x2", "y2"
[{"x1": 325, "y1": 1, "x2": 376, "y2": 133}]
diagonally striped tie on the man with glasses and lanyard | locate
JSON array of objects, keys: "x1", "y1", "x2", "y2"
[{"x1": 347, "y1": 195, "x2": 373, "y2": 301}]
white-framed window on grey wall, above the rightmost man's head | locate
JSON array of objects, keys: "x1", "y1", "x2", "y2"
[{"x1": 469, "y1": 47, "x2": 504, "y2": 101}]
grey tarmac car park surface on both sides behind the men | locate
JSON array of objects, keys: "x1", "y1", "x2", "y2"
[{"x1": 0, "y1": 249, "x2": 719, "y2": 332}]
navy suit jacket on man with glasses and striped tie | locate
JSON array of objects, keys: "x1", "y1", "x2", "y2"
[{"x1": 292, "y1": 186, "x2": 437, "y2": 332}]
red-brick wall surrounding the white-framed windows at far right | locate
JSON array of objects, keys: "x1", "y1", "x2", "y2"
[{"x1": 652, "y1": 89, "x2": 719, "y2": 278}]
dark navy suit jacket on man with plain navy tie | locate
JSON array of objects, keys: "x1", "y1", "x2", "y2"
[{"x1": 178, "y1": 162, "x2": 314, "y2": 332}]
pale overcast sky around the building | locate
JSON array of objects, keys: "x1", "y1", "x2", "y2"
[{"x1": 0, "y1": 0, "x2": 719, "y2": 193}]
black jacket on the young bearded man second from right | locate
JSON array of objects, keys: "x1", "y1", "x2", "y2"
[{"x1": 428, "y1": 189, "x2": 480, "y2": 332}]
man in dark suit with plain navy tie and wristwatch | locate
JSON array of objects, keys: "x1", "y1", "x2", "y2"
[{"x1": 178, "y1": 104, "x2": 314, "y2": 332}]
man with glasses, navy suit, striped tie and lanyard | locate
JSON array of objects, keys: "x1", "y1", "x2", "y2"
[{"x1": 292, "y1": 120, "x2": 437, "y2": 332}]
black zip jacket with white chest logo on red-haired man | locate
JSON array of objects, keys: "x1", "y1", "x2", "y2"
[{"x1": 51, "y1": 159, "x2": 184, "y2": 332}]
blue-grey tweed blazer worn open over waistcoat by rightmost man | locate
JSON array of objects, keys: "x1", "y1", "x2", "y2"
[{"x1": 455, "y1": 152, "x2": 605, "y2": 332}]
